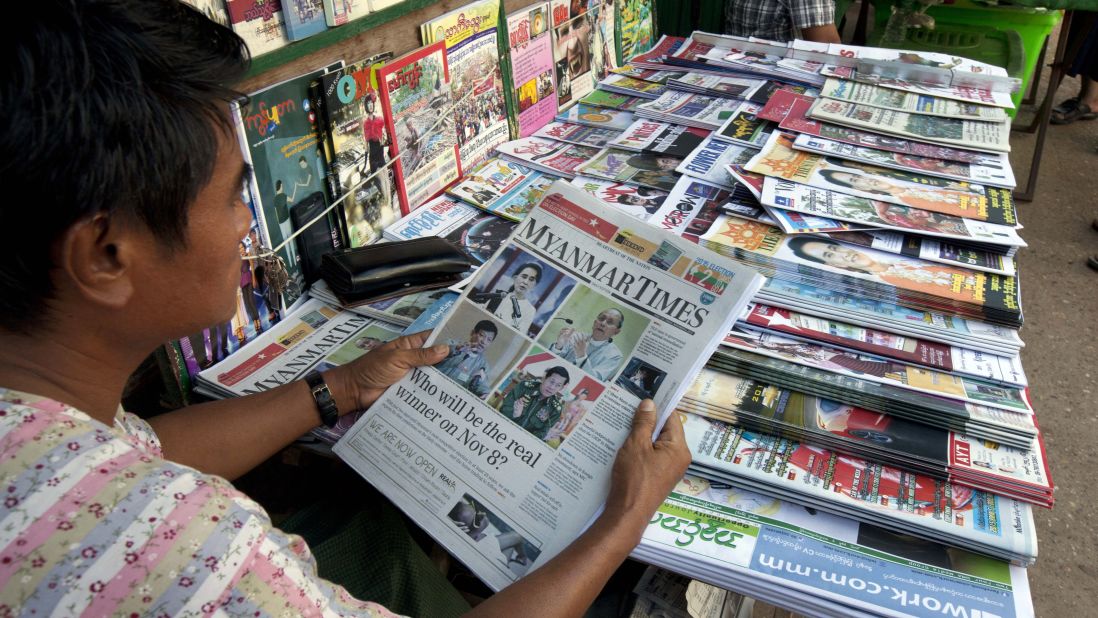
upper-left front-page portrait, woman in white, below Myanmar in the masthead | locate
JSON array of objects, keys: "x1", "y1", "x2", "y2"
[{"x1": 469, "y1": 247, "x2": 575, "y2": 338}]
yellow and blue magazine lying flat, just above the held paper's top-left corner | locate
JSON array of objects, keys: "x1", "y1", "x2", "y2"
[{"x1": 447, "y1": 158, "x2": 557, "y2": 222}]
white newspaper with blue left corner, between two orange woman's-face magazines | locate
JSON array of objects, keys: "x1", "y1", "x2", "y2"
[{"x1": 760, "y1": 177, "x2": 1026, "y2": 247}]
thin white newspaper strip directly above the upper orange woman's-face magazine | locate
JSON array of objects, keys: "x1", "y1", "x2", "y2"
[{"x1": 793, "y1": 134, "x2": 1017, "y2": 189}]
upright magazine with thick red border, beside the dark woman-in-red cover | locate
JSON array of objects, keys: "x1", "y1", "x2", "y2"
[{"x1": 374, "y1": 41, "x2": 461, "y2": 214}]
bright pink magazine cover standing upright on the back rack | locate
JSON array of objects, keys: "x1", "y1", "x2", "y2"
[{"x1": 507, "y1": 2, "x2": 557, "y2": 137}]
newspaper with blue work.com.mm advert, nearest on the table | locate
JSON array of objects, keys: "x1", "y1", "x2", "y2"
[{"x1": 634, "y1": 476, "x2": 1033, "y2": 618}]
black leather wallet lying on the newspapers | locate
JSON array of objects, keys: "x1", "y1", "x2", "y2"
[{"x1": 321, "y1": 236, "x2": 474, "y2": 305}]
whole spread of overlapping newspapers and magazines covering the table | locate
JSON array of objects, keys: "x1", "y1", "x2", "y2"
[{"x1": 469, "y1": 33, "x2": 1036, "y2": 616}]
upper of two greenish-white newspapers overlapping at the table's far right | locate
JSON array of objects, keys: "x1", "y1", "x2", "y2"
[{"x1": 820, "y1": 78, "x2": 1007, "y2": 122}]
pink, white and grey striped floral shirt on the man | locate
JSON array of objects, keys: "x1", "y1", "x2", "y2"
[{"x1": 0, "y1": 389, "x2": 404, "y2": 617}]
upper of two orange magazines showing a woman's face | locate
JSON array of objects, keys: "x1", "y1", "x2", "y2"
[{"x1": 743, "y1": 132, "x2": 1018, "y2": 227}]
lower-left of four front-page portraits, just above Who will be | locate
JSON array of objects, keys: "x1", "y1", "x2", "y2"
[{"x1": 435, "y1": 302, "x2": 530, "y2": 398}]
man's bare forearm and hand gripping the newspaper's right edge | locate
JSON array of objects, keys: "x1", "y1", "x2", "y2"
[{"x1": 468, "y1": 400, "x2": 691, "y2": 618}]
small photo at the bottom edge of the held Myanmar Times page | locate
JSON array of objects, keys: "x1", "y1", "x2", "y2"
[{"x1": 447, "y1": 494, "x2": 541, "y2": 575}]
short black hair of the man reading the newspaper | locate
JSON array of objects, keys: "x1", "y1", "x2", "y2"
[{"x1": 0, "y1": 0, "x2": 249, "y2": 334}]
